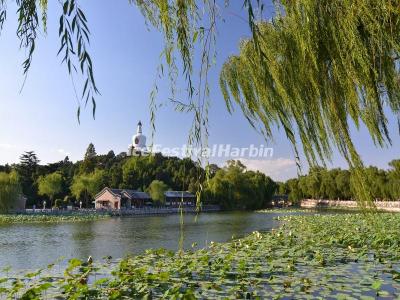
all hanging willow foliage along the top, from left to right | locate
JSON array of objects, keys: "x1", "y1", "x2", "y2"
[{"x1": 0, "y1": 0, "x2": 400, "y2": 203}]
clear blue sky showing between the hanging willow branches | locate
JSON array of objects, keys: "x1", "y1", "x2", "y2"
[{"x1": 0, "y1": 0, "x2": 400, "y2": 179}]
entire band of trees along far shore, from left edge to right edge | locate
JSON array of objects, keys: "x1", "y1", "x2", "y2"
[{"x1": 0, "y1": 144, "x2": 400, "y2": 211}]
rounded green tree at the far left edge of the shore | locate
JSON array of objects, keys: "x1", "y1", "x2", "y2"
[{"x1": 0, "y1": 171, "x2": 22, "y2": 212}]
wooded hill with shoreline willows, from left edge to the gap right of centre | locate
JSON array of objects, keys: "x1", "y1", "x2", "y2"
[{"x1": 0, "y1": 144, "x2": 277, "y2": 210}]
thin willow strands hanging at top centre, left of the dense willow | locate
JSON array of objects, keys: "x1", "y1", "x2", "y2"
[{"x1": 130, "y1": 0, "x2": 222, "y2": 210}]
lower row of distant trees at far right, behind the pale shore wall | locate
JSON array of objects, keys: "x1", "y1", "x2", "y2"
[{"x1": 278, "y1": 160, "x2": 400, "y2": 202}]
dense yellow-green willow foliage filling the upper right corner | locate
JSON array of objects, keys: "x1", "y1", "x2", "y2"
[{"x1": 220, "y1": 0, "x2": 400, "y2": 203}]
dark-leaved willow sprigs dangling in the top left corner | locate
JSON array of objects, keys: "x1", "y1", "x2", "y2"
[{"x1": 0, "y1": 0, "x2": 99, "y2": 121}]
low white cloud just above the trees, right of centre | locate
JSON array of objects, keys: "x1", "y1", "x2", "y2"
[{"x1": 240, "y1": 157, "x2": 297, "y2": 180}]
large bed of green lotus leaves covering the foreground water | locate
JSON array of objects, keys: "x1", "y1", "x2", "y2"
[{"x1": 0, "y1": 213, "x2": 400, "y2": 299}]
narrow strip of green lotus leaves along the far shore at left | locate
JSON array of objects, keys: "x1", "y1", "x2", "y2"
[{"x1": 0, "y1": 214, "x2": 109, "y2": 225}]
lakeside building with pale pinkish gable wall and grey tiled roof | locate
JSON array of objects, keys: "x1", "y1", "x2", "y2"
[{"x1": 95, "y1": 187, "x2": 151, "y2": 209}]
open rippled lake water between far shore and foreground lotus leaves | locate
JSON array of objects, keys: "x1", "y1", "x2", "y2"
[{"x1": 0, "y1": 212, "x2": 296, "y2": 270}]
